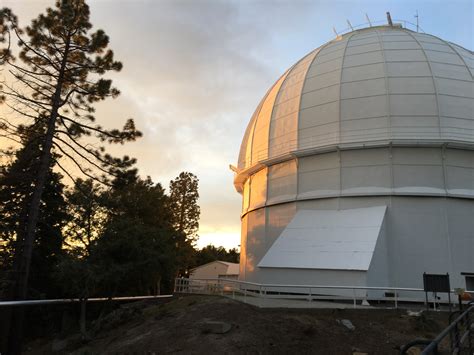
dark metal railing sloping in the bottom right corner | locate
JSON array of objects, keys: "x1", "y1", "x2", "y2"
[{"x1": 400, "y1": 302, "x2": 474, "y2": 355}]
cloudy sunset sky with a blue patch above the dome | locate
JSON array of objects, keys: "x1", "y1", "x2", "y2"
[{"x1": 0, "y1": 0, "x2": 474, "y2": 248}]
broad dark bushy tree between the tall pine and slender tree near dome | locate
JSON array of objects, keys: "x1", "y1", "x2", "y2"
[{"x1": 97, "y1": 171, "x2": 180, "y2": 296}]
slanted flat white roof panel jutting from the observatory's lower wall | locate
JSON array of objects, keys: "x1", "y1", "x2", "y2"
[{"x1": 258, "y1": 206, "x2": 386, "y2": 271}]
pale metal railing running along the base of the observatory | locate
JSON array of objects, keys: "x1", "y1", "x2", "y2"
[{"x1": 174, "y1": 278, "x2": 460, "y2": 308}]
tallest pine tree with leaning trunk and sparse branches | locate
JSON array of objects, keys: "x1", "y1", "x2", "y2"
[{"x1": 0, "y1": 0, "x2": 141, "y2": 353}]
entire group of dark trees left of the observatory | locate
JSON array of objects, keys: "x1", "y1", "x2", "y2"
[{"x1": 0, "y1": 0, "x2": 237, "y2": 353}]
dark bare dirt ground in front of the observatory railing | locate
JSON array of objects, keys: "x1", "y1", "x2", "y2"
[{"x1": 25, "y1": 296, "x2": 448, "y2": 355}]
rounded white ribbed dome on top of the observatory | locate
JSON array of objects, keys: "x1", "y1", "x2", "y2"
[{"x1": 237, "y1": 26, "x2": 474, "y2": 175}]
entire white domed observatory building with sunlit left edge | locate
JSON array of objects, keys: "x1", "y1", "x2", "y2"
[{"x1": 234, "y1": 20, "x2": 474, "y2": 296}]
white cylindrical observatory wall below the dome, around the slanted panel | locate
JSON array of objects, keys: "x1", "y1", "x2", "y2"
[{"x1": 240, "y1": 147, "x2": 474, "y2": 294}]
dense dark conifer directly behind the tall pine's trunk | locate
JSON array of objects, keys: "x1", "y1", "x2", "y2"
[{"x1": 0, "y1": 127, "x2": 69, "y2": 346}]
